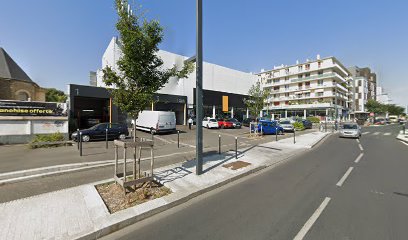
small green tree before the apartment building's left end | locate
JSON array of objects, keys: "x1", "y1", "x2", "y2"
[{"x1": 244, "y1": 82, "x2": 269, "y2": 117}]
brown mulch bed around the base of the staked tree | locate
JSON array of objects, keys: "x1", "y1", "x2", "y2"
[{"x1": 95, "y1": 182, "x2": 171, "y2": 213}]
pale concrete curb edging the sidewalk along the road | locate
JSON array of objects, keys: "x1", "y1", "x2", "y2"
[{"x1": 77, "y1": 133, "x2": 331, "y2": 240}]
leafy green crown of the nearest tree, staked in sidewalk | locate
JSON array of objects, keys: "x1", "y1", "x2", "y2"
[{"x1": 103, "y1": 0, "x2": 194, "y2": 118}]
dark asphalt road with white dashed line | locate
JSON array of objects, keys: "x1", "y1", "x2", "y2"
[{"x1": 103, "y1": 125, "x2": 408, "y2": 240}]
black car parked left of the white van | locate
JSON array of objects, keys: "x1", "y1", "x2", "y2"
[{"x1": 71, "y1": 123, "x2": 129, "y2": 142}]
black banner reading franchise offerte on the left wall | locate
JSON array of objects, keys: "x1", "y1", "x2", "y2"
[{"x1": 0, "y1": 100, "x2": 67, "y2": 116}]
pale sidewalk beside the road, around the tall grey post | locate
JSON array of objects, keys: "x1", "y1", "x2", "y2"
[{"x1": 0, "y1": 132, "x2": 329, "y2": 239}]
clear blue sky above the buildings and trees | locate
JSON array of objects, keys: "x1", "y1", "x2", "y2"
[{"x1": 0, "y1": 0, "x2": 408, "y2": 105}]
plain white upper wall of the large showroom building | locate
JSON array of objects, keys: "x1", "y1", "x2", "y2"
[{"x1": 97, "y1": 38, "x2": 258, "y2": 105}]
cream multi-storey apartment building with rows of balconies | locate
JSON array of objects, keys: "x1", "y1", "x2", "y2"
[{"x1": 257, "y1": 55, "x2": 350, "y2": 120}]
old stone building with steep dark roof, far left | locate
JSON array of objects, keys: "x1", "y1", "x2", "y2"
[{"x1": 0, "y1": 48, "x2": 46, "y2": 101}]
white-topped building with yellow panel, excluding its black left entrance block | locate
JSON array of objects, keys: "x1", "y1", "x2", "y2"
[{"x1": 97, "y1": 37, "x2": 257, "y2": 124}]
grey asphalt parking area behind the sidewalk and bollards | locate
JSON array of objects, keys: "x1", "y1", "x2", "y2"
[{"x1": 0, "y1": 125, "x2": 316, "y2": 173}]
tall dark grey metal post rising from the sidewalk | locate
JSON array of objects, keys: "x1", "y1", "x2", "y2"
[{"x1": 196, "y1": 0, "x2": 203, "y2": 175}]
